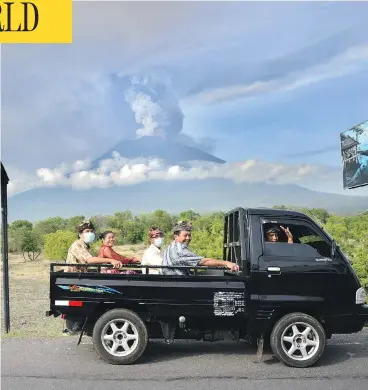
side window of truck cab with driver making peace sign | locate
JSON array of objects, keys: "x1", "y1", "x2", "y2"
[{"x1": 262, "y1": 220, "x2": 331, "y2": 258}]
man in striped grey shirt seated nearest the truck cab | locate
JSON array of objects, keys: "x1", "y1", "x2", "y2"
[{"x1": 160, "y1": 221, "x2": 239, "y2": 275}]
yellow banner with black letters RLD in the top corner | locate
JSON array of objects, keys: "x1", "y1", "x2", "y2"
[{"x1": 0, "y1": 0, "x2": 73, "y2": 43}]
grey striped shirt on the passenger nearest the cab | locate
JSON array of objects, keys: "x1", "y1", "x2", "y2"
[{"x1": 160, "y1": 241, "x2": 203, "y2": 275}]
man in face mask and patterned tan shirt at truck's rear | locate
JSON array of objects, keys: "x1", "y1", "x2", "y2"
[{"x1": 66, "y1": 221, "x2": 122, "y2": 272}]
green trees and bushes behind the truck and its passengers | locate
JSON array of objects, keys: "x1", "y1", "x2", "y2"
[{"x1": 5, "y1": 205, "x2": 368, "y2": 286}]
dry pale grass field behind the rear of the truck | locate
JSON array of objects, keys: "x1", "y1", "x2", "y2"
[{"x1": 1, "y1": 245, "x2": 145, "y2": 337}]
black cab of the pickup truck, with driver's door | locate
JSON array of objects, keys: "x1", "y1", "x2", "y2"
[{"x1": 224, "y1": 208, "x2": 365, "y2": 337}]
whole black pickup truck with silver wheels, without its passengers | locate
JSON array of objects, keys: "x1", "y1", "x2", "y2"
[{"x1": 47, "y1": 208, "x2": 368, "y2": 367}]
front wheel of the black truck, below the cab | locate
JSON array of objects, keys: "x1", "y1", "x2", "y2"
[{"x1": 270, "y1": 313, "x2": 326, "y2": 368}]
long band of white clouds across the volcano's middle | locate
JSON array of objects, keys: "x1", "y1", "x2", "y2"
[{"x1": 9, "y1": 153, "x2": 340, "y2": 195}]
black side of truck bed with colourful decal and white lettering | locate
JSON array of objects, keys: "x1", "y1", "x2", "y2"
[{"x1": 49, "y1": 267, "x2": 246, "y2": 325}]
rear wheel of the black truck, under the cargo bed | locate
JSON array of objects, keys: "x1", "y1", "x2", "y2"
[{"x1": 92, "y1": 309, "x2": 148, "y2": 365}]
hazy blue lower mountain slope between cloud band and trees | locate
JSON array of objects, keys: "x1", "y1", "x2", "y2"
[{"x1": 8, "y1": 179, "x2": 368, "y2": 221}]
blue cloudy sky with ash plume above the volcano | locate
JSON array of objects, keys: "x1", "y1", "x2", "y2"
[{"x1": 1, "y1": 1, "x2": 368, "y2": 195}]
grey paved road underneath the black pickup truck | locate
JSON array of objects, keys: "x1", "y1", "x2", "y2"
[{"x1": 1, "y1": 329, "x2": 368, "y2": 390}]
